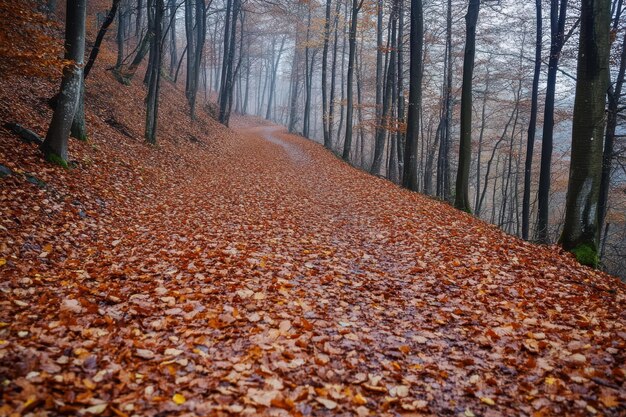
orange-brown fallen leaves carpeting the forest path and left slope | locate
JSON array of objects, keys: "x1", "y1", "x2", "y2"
[{"x1": 0, "y1": 55, "x2": 626, "y2": 417}]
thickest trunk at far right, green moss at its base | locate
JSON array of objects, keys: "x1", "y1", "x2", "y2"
[{"x1": 560, "y1": 0, "x2": 610, "y2": 266}]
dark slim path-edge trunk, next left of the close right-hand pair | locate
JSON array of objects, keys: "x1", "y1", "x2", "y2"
[{"x1": 454, "y1": 0, "x2": 480, "y2": 213}]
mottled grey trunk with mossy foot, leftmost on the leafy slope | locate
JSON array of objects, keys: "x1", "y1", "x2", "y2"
[{"x1": 41, "y1": 0, "x2": 87, "y2": 166}]
